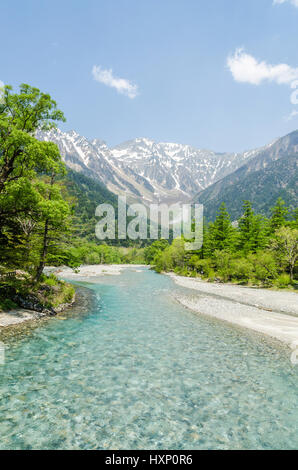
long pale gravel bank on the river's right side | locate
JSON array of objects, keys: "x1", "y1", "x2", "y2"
[{"x1": 167, "y1": 273, "x2": 298, "y2": 349}]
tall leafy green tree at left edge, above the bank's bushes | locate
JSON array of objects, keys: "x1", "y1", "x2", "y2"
[{"x1": 0, "y1": 84, "x2": 67, "y2": 278}]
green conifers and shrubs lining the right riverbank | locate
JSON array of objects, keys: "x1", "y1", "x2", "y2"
[{"x1": 151, "y1": 199, "x2": 298, "y2": 288}]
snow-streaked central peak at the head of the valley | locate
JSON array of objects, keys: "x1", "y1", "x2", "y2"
[{"x1": 111, "y1": 139, "x2": 264, "y2": 199}]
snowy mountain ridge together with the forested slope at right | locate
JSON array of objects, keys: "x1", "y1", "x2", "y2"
[{"x1": 37, "y1": 129, "x2": 298, "y2": 219}]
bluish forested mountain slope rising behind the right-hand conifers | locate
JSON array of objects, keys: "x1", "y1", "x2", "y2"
[{"x1": 195, "y1": 131, "x2": 298, "y2": 220}]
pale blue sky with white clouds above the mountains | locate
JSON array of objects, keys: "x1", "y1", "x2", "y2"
[{"x1": 0, "y1": 0, "x2": 298, "y2": 151}]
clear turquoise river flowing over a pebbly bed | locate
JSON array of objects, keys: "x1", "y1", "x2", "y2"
[{"x1": 0, "y1": 269, "x2": 298, "y2": 450}]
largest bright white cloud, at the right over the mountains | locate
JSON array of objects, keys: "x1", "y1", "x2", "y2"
[{"x1": 227, "y1": 49, "x2": 298, "y2": 85}]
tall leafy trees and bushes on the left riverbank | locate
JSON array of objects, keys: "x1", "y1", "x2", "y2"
[{"x1": 0, "y1": 85, "x2": 73, "y2": 311}]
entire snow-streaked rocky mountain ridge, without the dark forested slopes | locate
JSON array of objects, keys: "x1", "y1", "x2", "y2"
[{"x1": 37, "y1": 130, "x2": 278, "y2": 203}]
